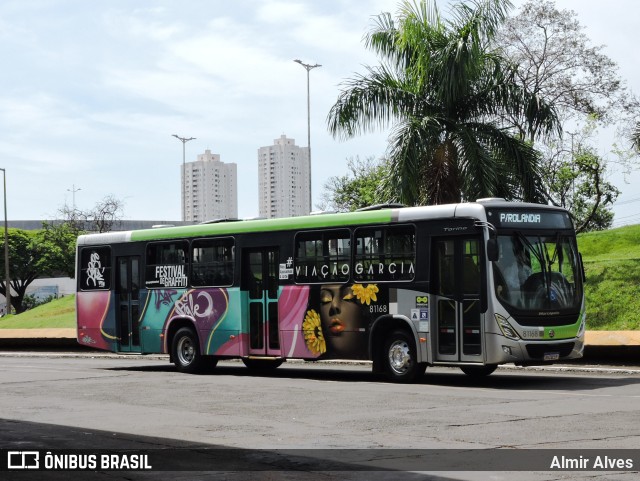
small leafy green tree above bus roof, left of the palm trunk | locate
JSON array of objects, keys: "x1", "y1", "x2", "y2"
[{"x1": 321, "y1": 157, "x2": 389, "y2": 212}]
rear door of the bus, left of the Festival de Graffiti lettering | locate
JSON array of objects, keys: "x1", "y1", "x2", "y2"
[{"x1": 116, "y1": 256, "x2": 141, "y2": 352}]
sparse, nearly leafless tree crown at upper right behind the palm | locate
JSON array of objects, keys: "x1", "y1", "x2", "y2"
[{"x1": 495, "y1": 0, "x2": 640, "y2": 142}]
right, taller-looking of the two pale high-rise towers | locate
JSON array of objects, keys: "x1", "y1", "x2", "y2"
[{"x1": 258, "y1": 135, "x2": 311, "y2": 218}]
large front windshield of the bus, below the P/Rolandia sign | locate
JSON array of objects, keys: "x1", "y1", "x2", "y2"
[{"x1": 494, "y1": 232, "x2": 582, "y2": 311}]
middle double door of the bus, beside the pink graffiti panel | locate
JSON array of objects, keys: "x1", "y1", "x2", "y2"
[{"x1": 243, "y1": 247, "x2": 281, "y2": 357}]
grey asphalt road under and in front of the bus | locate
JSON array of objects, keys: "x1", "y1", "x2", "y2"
[{"x1": 0, "y1": 353, "x2": 640, "y2": 480}]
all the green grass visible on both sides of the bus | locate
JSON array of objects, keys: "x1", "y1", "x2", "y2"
[{"x1": 0, "y1": 225, "x2": 640, "y2": 331}]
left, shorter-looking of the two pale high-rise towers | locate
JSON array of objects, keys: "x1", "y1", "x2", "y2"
[{"x1": 182, "y1": 150, "x2": 238, "y2": 223}]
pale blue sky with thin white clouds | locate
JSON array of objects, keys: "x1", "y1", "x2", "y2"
[{"x1": 0, "y1": 0, "x2": 640, "y2": 226}]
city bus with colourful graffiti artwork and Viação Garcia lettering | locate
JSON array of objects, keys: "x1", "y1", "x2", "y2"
[{"x1": 76, "y1": 199, "x2": 585, "y2": 382}]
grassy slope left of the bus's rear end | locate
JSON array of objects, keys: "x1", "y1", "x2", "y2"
[{"x1": 0, "y1": 295, "x2": 76, "y2": 329}]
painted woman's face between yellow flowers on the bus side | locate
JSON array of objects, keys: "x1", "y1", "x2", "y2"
[{"x1": 320, "y1": 285, "x2": 362, "y2": 351}]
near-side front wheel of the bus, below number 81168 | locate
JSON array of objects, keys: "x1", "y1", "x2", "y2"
[{"x1": 382, "y1": 330, "x2": 427, "y2": 383}]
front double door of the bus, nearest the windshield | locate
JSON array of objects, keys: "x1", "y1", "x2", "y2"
[{"x1": 432, "y1": 236, "x2": 483, "y2": 362}]
